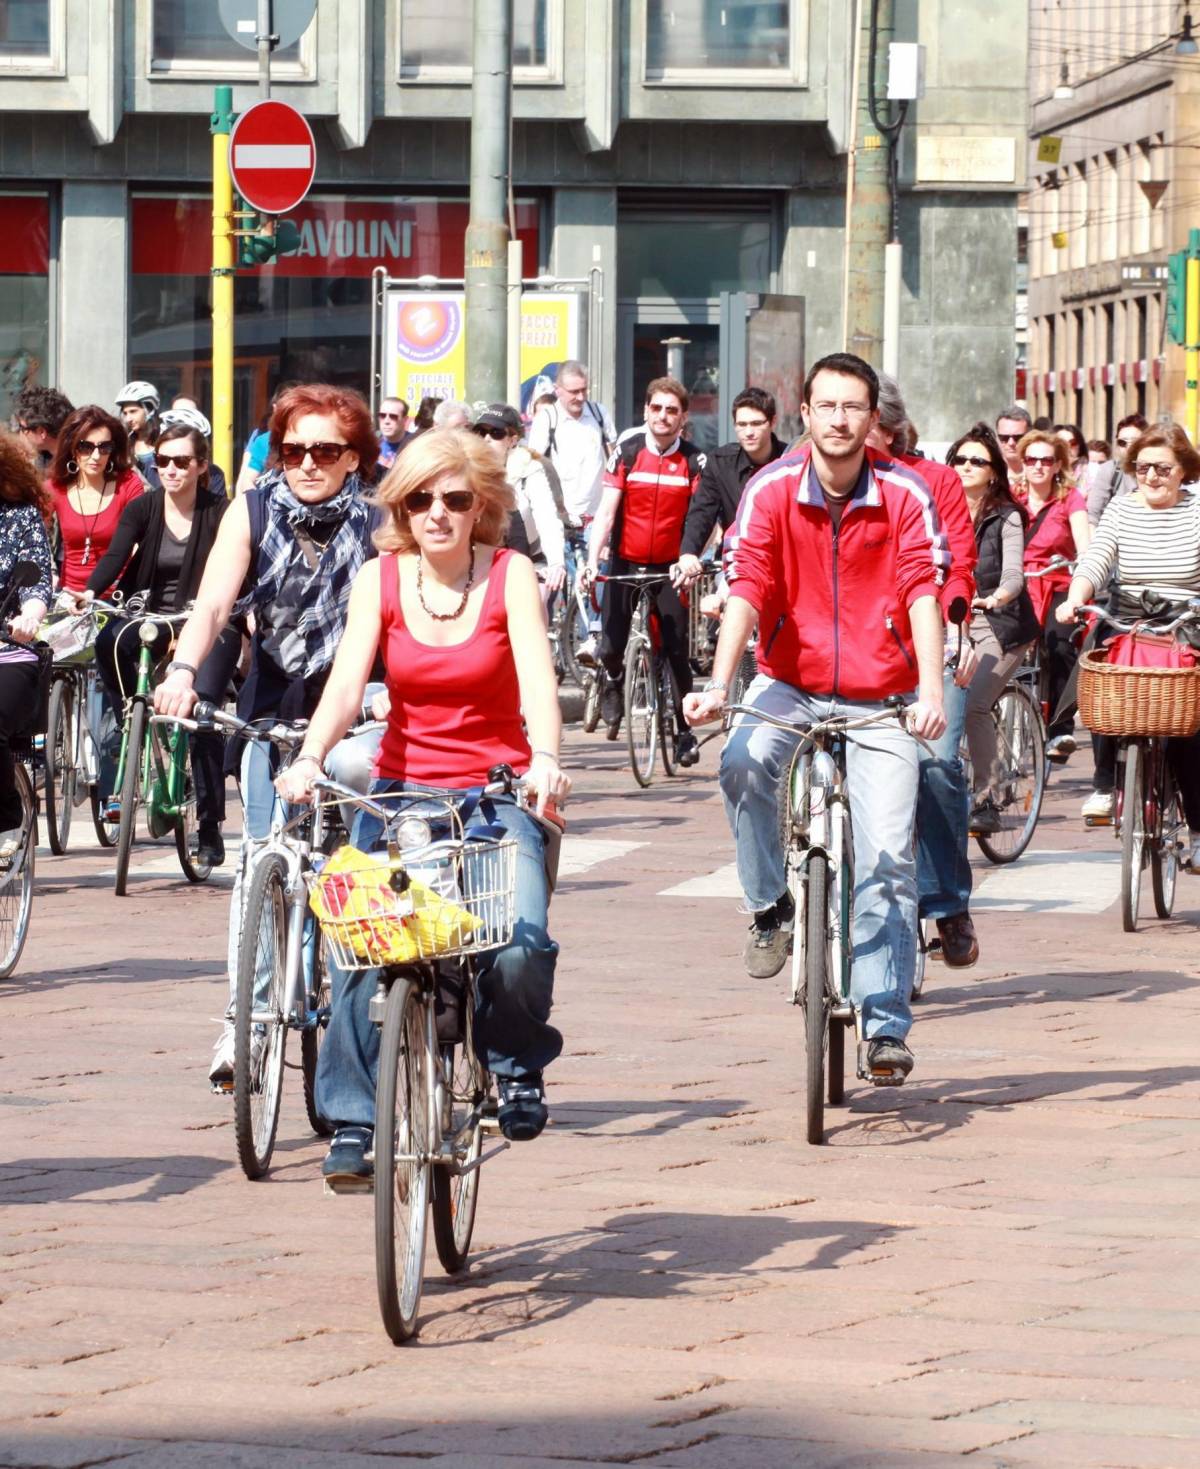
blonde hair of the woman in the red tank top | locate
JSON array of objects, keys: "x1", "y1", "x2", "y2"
[{"x1": 372, "y1": 429, "x2": 516, "y2": 552}]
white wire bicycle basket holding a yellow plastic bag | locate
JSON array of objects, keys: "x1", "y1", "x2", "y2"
[{"x1": 310, "y1": 839, "x2": 517, "y2": 970}]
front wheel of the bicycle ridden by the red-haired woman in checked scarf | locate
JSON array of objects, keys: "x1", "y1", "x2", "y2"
[{"x1": 234, "y1": 855, "x2": 288, "y2": 1178}]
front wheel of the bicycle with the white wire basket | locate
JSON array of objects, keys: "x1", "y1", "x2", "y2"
[{"x1": 375, "y1": 980, "x2": 433, "y2": 1346}]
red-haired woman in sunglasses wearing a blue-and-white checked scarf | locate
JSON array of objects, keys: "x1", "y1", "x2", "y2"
[{"x1": 154, "y1": 383, "x2": 379, "y2": 1089}]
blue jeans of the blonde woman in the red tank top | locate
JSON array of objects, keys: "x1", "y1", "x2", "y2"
[{"x1": 317, "y1": 780, "x2": 563, "y2": 1127}]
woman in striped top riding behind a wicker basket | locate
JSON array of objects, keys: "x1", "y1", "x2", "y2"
[{"x1": 1058, "y1": 423, "x2": 1200, "y2": 873}]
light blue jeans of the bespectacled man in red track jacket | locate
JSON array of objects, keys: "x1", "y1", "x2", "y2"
[{"x1": 721, "y1": 673, "x2": 919, "y2": 1040}]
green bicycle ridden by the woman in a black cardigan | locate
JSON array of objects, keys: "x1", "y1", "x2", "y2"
[{"x1": 113, "y1": 596, "x2": 212, "y2": 898}]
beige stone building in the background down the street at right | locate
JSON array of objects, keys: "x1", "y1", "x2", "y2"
[{"x1": 1027, "y1": 0, "x2": 1200, "y2": 439}]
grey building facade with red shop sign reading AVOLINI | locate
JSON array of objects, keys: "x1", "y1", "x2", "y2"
[{"x1": 0, "y1": 0, "x2": 1025, "y2": 467}]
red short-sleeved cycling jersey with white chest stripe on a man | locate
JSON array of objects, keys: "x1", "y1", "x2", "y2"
[{"x1": 604, "y1": 432, "x2": 705, "y2": 566}]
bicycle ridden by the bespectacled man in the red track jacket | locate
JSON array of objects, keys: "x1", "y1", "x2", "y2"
[{"x1": 726, "y1": 699, "x2": 925, "y2": 1144}]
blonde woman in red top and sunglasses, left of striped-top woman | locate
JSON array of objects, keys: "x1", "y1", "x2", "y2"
[{"x1": 1013, "y1": 429, "x2": 1088, "y2": 764}]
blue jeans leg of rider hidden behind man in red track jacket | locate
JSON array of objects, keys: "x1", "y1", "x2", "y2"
[{"x1": 917, "y1": 668, "x2": 971, "y2": 918}]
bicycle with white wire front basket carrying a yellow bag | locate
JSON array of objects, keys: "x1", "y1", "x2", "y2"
[{"x1": 313, "y1": 765, "x2": 561, "y2": 1344}]
